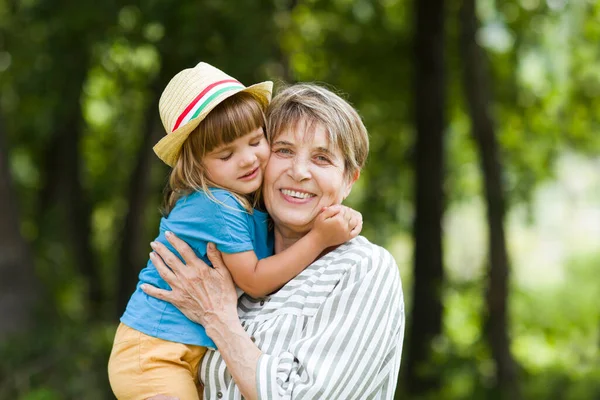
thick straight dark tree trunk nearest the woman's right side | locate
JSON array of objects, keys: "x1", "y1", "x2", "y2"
[{"x1": 406, "y1": 0, "x2": 445, "y2": 395}]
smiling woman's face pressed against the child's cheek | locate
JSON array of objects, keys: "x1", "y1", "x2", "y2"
[{"x1": 263, "y1": 122, "x2": 358, "y2": 233}]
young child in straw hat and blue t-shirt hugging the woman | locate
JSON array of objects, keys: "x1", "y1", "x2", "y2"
[{"x1": 108, "y1": 63, "x2": 359, "y2": 400}]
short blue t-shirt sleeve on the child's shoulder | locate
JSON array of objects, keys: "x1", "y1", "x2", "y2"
[{"x1": 165, "y1": 191, "x2": 254, "y2": 255}]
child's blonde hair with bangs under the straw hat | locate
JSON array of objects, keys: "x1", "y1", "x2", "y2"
[{"x1": 163, "y1": 92, "x2": 268, "y2": 216}]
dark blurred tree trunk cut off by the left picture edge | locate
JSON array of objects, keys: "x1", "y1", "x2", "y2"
[{"x1": 0, "y1": 108, "x2": 39, "y2": 342}]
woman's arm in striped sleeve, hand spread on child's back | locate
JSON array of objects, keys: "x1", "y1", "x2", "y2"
[{"x1": 143, "y1": 236, "x2": 404, "y2": 399}]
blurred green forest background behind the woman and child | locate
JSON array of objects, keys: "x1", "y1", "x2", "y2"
[{"x1": 0, "y1": 0, "x2": 600, "y2": 400}]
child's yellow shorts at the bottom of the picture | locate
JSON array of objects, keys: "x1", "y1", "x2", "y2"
[{"x1": 108, "y1": 324, "x2": 206, "y2": 400}]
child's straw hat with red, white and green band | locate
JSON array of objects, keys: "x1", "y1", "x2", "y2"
[{"x1": 154, "y1": 62, "x2": 273, "y2": 167}]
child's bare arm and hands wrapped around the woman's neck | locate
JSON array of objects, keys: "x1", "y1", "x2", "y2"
[{"x1": 223, "y1": 205, "x2": 362, "y2": 298}]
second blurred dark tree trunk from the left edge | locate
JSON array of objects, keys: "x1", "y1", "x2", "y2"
[{"x1": 37, "y1": 49, "x2": 103, "y2": 319}]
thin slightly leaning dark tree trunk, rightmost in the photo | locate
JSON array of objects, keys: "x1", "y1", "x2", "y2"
[{"x1": 460, "y1": 0, "x2": 520, "y2": 400}]
